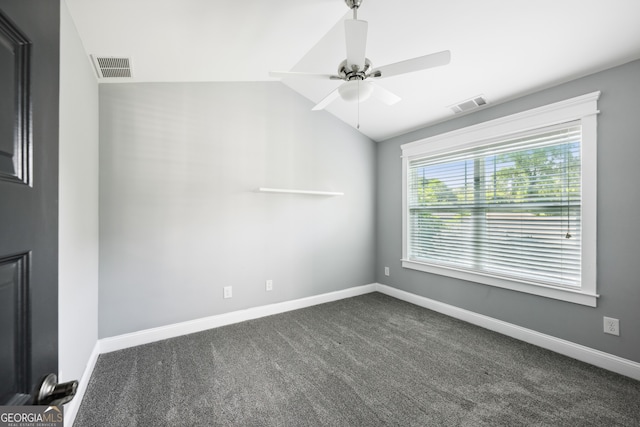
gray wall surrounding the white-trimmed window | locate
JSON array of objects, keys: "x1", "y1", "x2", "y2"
[{"x1": 376, "y1": 61, "x2": 640, "y2": 362}]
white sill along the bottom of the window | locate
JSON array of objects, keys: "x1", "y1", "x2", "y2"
[{"x1": 402, "y1": 259, "x2": 599, "y2": 307}]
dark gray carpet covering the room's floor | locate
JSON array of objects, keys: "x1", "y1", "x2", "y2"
[{"x1": 74, "y1": 293, "x2": 640, "y2": 427}]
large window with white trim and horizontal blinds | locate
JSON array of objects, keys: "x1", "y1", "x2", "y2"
[{"x1": 402, "y1": 93, "x2": 599, "y2": 306}]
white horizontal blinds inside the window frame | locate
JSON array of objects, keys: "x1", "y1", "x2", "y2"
[{"x1": 406, "y1": 121, "x2": 582, "y2": 288}]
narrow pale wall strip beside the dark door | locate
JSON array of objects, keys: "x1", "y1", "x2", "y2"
[{"x1": 58, "y1": 1, "x2": 98, "y2": 381}]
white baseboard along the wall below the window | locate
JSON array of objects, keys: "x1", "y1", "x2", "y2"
[{"x1": 376, "y1": 284, "x2": 640, "y2": 380}]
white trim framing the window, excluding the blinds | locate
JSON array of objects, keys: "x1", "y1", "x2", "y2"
[{"x1": 401, "y1": 91, "x2": 600, "y2": 307}]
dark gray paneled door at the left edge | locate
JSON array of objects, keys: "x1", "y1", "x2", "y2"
[{"x1": 0, "y1": 0, "x2": 60, "y2": 405}]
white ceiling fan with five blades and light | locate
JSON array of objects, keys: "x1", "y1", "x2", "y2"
[{"x1": 269, "y1": 0, "x2": 451, "y2": 110}]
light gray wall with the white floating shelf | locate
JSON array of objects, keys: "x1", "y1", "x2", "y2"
[{"x1": 99, "y1": 82, "x2": 376, "y2": 338}]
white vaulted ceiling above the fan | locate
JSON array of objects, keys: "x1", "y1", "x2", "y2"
[{"x1": 66, "y1": 0, "x2": 640, "y2": 141}]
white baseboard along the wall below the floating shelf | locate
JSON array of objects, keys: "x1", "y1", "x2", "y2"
[{"x1": 99, "y1": 284, "x2": 376, "y2": 353}]
